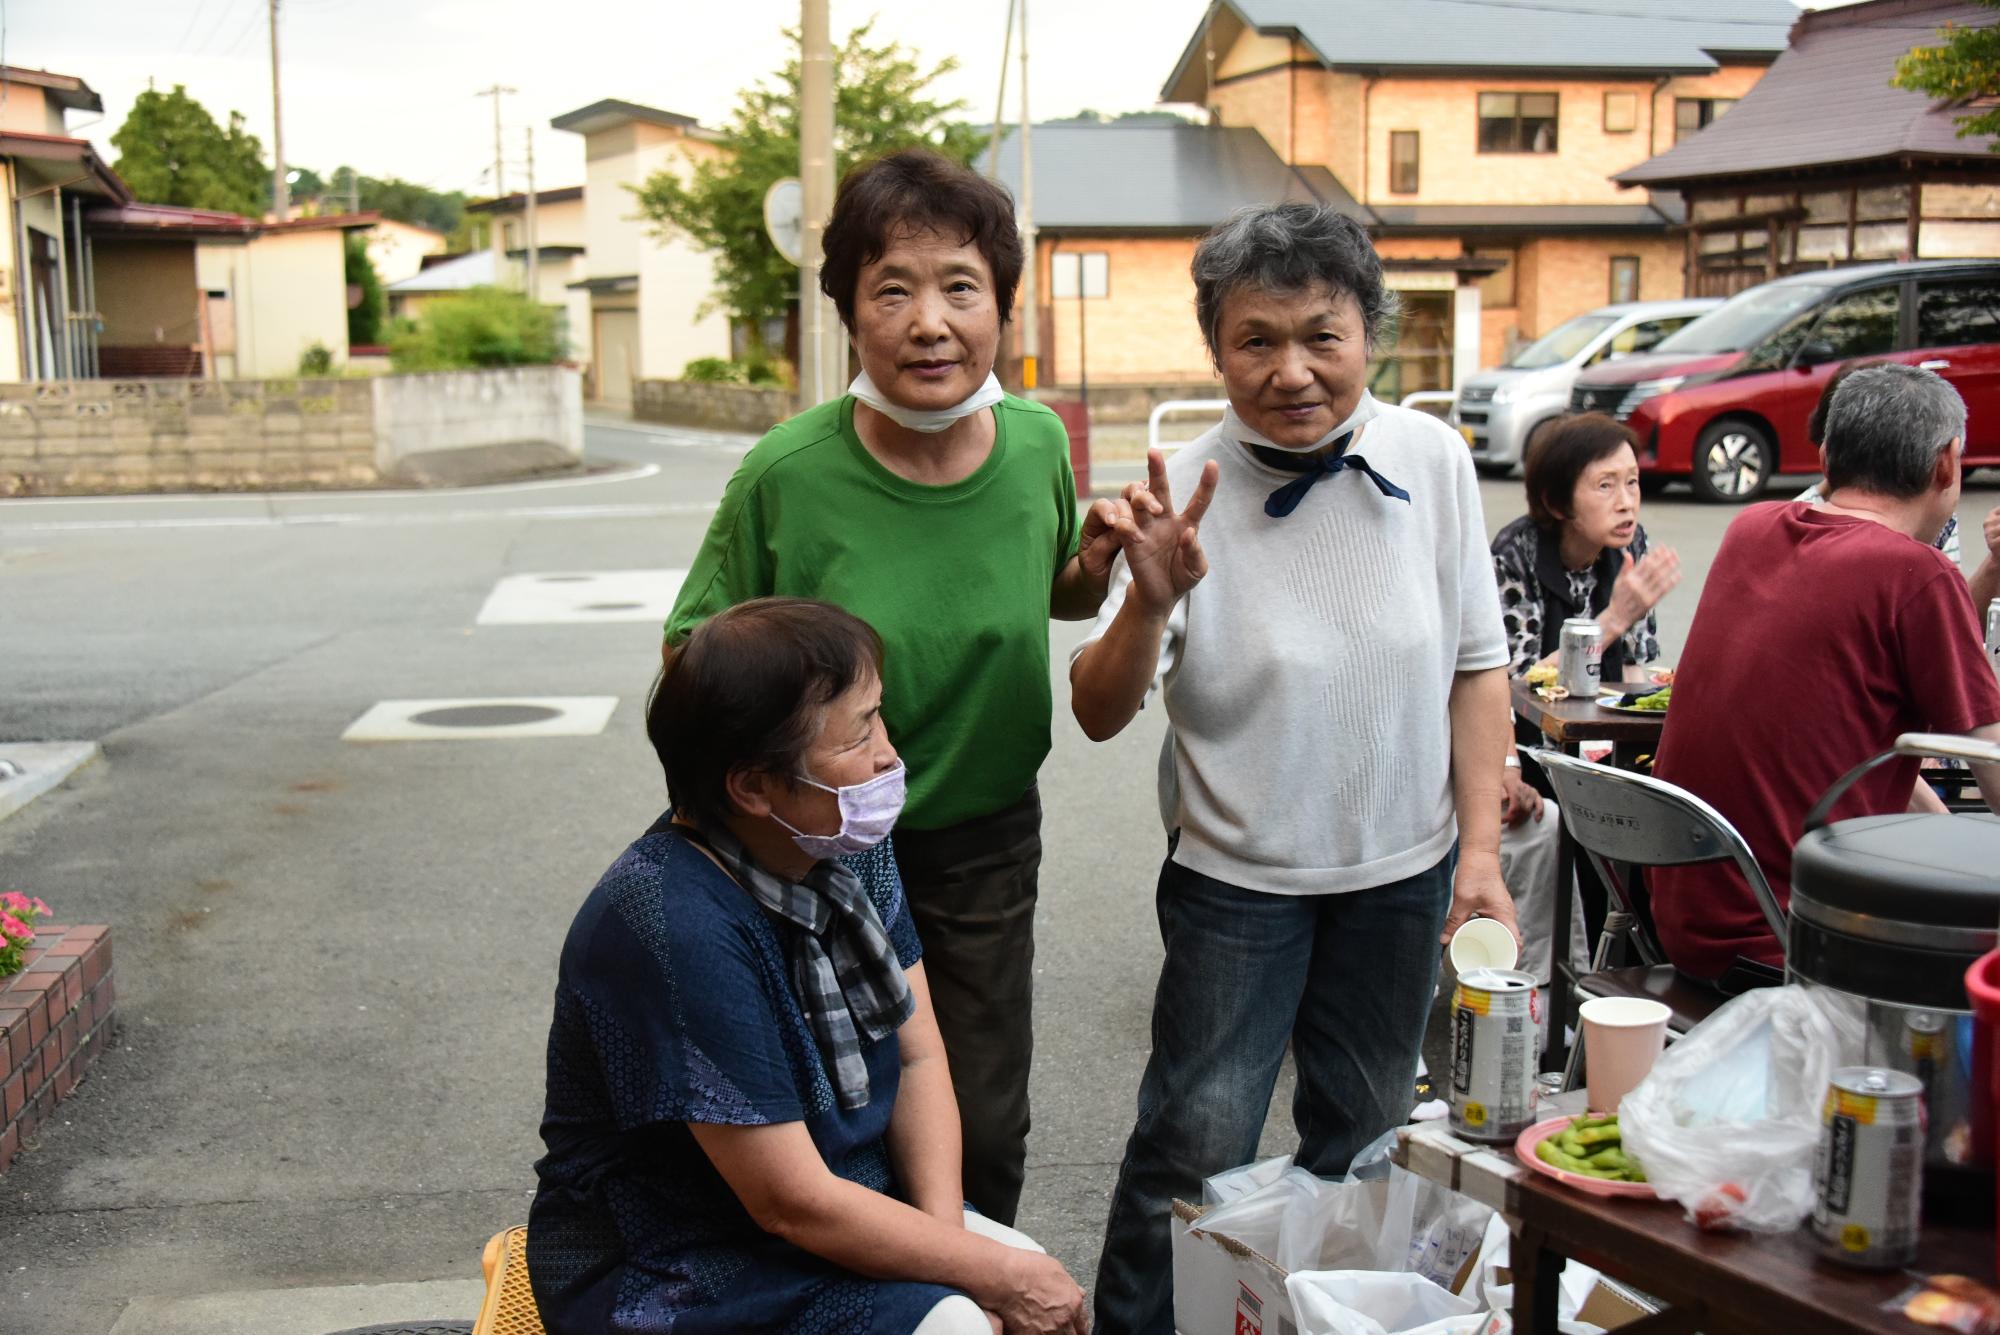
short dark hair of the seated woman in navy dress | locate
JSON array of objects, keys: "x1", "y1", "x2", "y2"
[{"x1": 646, "y1": 598, "x2": 882, "y2": 827}]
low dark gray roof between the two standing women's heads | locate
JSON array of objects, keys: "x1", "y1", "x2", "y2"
[{"x1": 1000, "y1": 124, "x2": 1370, "y2": 232}]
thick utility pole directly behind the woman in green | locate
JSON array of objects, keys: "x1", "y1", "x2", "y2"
[{"x1": 798, "y1": 0, "x2": 846, "y2": 408}]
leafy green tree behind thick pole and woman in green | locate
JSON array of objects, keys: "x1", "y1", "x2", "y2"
[{"x1": 636, "y1": 22, "x2": 986, "y2": 341}]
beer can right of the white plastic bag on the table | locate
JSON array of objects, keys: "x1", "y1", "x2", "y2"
[{"x1": 1812, "y1": 1065, "x2": 1924, "y2": 1269}]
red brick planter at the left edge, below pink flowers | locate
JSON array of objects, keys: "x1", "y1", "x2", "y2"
[{"x1": 0, "y1": 923, "x2": 114, "y2": 1173}]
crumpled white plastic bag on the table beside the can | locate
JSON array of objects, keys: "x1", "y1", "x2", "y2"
[{"x1": 1618, "y1": 985, "x2": 1866, "y2": 1233}]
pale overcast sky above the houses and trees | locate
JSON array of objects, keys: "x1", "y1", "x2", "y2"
[{"x1": 11, "y1": 0, "x2": 1208, "y2": 194}]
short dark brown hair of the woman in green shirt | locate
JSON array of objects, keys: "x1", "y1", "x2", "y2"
[{"x1": 820, "y1": 148, "x2": 1022, "y2": 332}]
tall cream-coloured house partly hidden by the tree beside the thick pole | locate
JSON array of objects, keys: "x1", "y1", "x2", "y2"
[{"x1": 548, "y1": 100, "x2": 730, "y2": 406}]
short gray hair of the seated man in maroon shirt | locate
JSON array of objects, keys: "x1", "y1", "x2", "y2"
[{"x1": 1822, "y1": 362, "x2": 1966, "y2": 500}]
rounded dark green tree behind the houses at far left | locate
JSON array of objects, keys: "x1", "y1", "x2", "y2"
[{"x1": 112, "y1": 84, "x2": 270, "y2": 218}]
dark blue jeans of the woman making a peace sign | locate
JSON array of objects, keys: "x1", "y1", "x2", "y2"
[{"x1": 1092, "y1": 849, "x2": 1458, "y2": 1335}]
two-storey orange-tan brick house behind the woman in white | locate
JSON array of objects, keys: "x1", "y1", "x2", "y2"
[{"x1": 1002, "y1": 0, "x2": 1798, "y2": 394}]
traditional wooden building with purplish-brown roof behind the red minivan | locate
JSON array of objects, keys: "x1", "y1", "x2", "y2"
[{"x1": 1618, "y1": 0, "x2": 2000, "y2": 296}]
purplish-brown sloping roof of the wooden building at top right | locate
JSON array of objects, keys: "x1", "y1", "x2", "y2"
[{"x1": 1614, "y1": 0, "x2": 1994, "y2": 186}]
